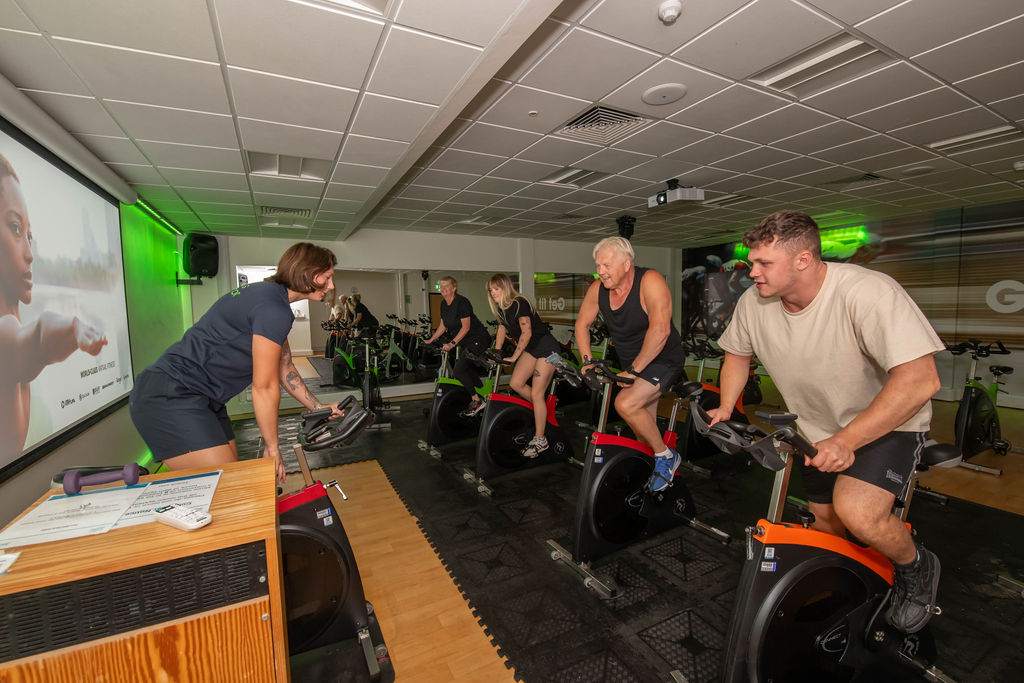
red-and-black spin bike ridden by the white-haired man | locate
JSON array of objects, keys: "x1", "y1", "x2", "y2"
[{"x1": 546, "y1": 353, "x2": 729, "y2": 598}]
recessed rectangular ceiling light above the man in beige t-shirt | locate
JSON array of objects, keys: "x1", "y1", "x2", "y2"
[{"x1": 751, "y1": 33, "x2": 895, "y2": 97}]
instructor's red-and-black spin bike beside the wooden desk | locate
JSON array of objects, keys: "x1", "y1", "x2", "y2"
[{"x1": 278, "y1": 396, "x2": 394, "y2": 682}]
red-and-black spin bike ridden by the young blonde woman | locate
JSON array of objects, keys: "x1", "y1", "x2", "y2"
[{"x1": 463, "y1": 349, "x2": 572, "y2": 496}]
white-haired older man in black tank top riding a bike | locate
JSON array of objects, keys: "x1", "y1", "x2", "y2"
[{"x1": 575, "y1": 238, "x2": 685, "y2": 490}]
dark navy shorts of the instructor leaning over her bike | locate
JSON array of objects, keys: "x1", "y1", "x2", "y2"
[{"x1": 128, "y1": 370, "x2": 234, "y2": 461}]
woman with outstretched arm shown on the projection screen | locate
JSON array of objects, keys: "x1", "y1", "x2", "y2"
[{"x1": 0, "y1": 155, "x2": 106, "y2": 467}]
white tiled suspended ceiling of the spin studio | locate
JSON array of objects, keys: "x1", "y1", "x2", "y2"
[{"x1": 0, "y1": 0, "x2": 1024, "y2": 247}]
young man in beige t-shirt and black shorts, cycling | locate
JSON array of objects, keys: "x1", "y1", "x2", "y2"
[{"x1": 710, "y1": 211, "x2": 943, "y2": 633}]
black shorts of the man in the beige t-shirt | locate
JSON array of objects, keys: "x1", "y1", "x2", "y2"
[{"x1": 803, "y1": 432, "x2": 927, "y2": 505}]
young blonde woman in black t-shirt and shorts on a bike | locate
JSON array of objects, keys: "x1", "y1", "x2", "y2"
[{"x1": 487, "y1": 273, "x2": 559, "y2": 458}]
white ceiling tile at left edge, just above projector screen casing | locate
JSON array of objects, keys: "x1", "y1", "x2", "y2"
[{"x1": 0, "y1": 29, "x2": 89, "y2": 95}]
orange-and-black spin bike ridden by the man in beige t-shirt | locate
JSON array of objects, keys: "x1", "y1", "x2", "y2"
[{"x1": 690, "y1": 400, "x2": 959, "y2": 683}]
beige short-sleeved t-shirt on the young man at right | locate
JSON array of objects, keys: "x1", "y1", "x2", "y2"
[{"x1": 718, "y1": 263, "x2": 945, "y2": 441}]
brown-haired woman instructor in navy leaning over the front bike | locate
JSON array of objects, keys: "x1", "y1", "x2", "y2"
[{"x1": 129, "y1": 243, "x2": 342, "y2": 482}]
